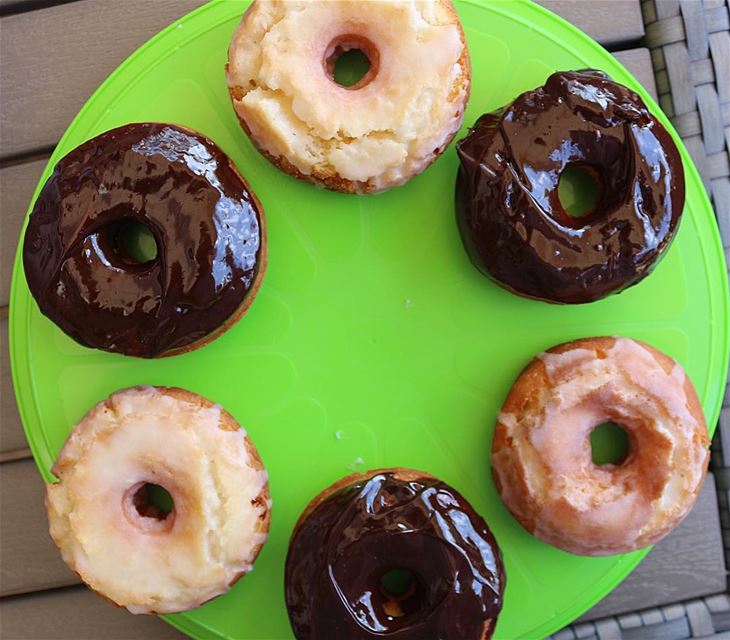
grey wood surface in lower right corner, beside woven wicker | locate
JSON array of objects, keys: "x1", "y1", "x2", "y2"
[{"x1": 580, "y1": 474, "x2": 727, "y2": 620}]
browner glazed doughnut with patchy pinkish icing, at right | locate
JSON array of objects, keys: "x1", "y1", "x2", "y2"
[{"x1": 492, "y1": 338, "x2": 710, "y2": 556}]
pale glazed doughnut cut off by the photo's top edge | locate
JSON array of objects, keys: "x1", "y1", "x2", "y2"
[{"x1": 226, "y1": 0, "x2": 471, "y2": 193}]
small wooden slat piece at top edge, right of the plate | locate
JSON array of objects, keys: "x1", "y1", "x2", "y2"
[{"x1": 536, "y1": 0, "x2": 644, "y2": 47}]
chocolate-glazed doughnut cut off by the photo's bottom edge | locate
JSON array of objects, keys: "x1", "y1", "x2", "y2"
[{"x1": 285, "y1": 469, "x2": 505, "y2": 640}]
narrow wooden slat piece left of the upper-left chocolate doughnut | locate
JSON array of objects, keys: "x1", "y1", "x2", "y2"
[{"x1": 0, "y1": 158, "x2": 48, "y2": 307}]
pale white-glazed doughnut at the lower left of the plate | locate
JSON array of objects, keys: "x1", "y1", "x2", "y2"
[{"x1": 46, "y1": 387, "x2": 271, "y2": 614}]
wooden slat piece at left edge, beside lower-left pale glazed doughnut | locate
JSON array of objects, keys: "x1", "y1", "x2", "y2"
[{"x1": 0, "y1": 459, "x2": 79, "y2": 596}]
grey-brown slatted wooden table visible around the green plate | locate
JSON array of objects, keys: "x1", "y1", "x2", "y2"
[{"x1": 0, "y1": 0, "x2": 726, "y2": 639}]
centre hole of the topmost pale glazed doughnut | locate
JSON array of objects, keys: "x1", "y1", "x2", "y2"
[{"x1": 323, "y1": 34, "x2": 380, "y2": 90}]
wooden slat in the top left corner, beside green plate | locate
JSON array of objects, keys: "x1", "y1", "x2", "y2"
[{"x1": 0, "y1": 0, "x2": 203, "y2": 158}]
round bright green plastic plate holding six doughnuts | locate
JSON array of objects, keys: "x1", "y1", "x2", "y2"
[{"x1": 10, "y1": 0, "x2": 728, "y2": 640}]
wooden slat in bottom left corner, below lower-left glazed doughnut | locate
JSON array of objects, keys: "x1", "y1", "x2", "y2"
[{"x1": 0, "y1": 587, "x2": 186, "y2": 640}]
